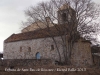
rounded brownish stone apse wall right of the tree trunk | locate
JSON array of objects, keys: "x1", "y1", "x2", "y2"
[{"x1": 71, "y1": 39, "x2": 93, "y2": 66}]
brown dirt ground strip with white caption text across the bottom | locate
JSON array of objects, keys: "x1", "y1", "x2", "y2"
[{"x1": 0, "y1": 65, "x2": 100, "y2": 75}]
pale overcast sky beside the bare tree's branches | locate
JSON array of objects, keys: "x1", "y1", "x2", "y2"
[{"x1": 0, "y1": 0, "x2": 100, "y2": 52}]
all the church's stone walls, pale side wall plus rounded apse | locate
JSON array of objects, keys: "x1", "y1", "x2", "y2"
[{"x1": 3, "y1": 37, "x2": 92, "y2": 66}]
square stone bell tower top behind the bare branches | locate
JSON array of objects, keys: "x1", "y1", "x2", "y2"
[{"x1": 58, "y1": 4, "x2": 76, "y2": 25}]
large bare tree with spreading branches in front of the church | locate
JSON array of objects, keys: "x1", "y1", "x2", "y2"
[{"x1": 21, "y1": 0, "x2": 100, "y2": 64}]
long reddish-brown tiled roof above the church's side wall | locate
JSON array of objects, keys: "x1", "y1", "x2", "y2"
[{"x1": 4, "y1": 25, "x2": 65, "y2": 43}]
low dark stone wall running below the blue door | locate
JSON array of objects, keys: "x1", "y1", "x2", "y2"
[{"x1": 0, "y1": 59, "x2": 52, "y2": 68}]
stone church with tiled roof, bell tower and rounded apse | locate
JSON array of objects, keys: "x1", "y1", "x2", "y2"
[{"x1": 3, "y1": 5, "x2": 92, "y2": 65}]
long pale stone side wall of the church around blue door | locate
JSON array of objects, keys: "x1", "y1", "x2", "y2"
[{"x1": 3, "y1": 37, "x2": 63, "y2": 61}]
